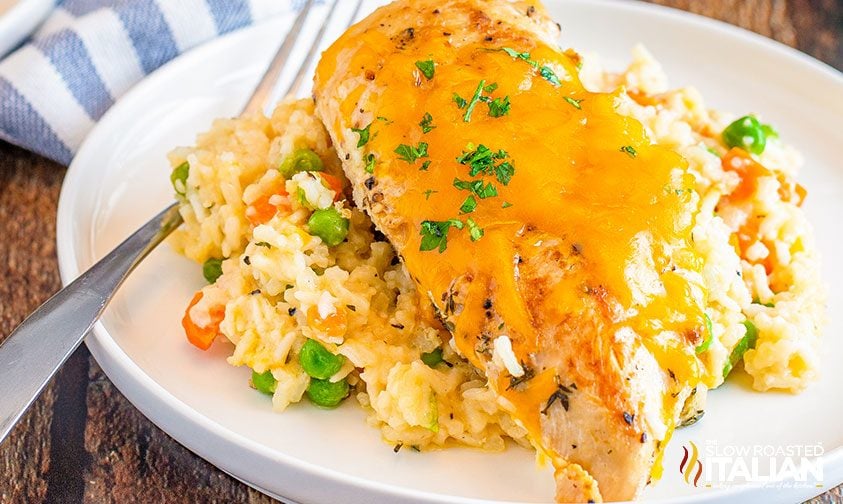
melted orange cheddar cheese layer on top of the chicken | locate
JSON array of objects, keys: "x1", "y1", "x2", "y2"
[{"x1": 317, "y1": 5, "x2": 704, "y2": 472}]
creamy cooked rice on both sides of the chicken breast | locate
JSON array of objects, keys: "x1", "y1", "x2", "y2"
[{"x1": 170, "y1": 48, "x2": 825, "y2": 450}]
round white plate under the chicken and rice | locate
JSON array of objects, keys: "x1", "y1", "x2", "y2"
[{"x1": 58, "y1": 1, "x2": 843, "y2": 503}]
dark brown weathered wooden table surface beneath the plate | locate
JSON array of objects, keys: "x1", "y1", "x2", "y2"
[{"x1": 0, "y1": 0, "x2": 843, "y2": 504}]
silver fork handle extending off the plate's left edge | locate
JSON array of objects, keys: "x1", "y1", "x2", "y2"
[{"x1": 0, "y1": 203, "x2": 182, "y2": 443}]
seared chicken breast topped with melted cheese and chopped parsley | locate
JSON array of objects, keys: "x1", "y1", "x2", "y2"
[{"x1": 314, "y1": 0, "x2": 706, "y2": 502}]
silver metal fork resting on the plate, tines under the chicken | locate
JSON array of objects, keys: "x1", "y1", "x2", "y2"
[{"x1": 0, "y1": 0, "x2": 363, "y2": 442}]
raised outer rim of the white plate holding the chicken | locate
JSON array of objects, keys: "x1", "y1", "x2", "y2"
[{"x1": 56, "y1": 0, "x2": 843, "y2": 504}]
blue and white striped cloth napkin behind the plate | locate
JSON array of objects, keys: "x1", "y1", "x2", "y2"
[{"x1": 0, "y1": 0, "x2": 303, "y2": 164}]
